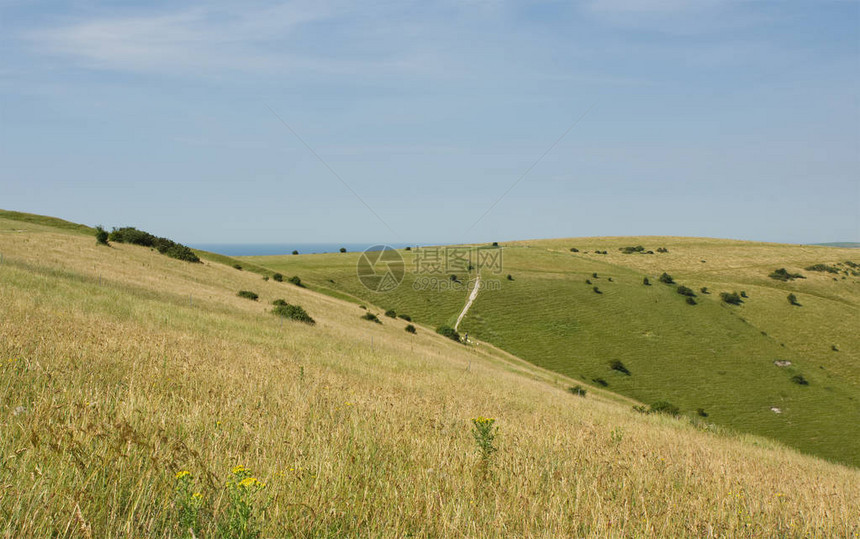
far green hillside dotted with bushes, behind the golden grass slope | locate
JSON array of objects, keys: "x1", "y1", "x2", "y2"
[{"x1": 247, "y1": 237, "x2": 860, "y2": 466}]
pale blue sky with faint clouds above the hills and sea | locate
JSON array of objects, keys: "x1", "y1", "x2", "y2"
[{"x1": 0, "y1": 0, "x2": 860, "y2": 243}]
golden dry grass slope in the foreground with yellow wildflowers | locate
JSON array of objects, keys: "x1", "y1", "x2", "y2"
[{"x1": 0, "y1": 218, "x2": 860, "y2": 538}]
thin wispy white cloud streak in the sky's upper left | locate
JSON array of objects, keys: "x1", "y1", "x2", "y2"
[{"x1": 23, "y1": 1, "x2": 430, "y2": 75}]
